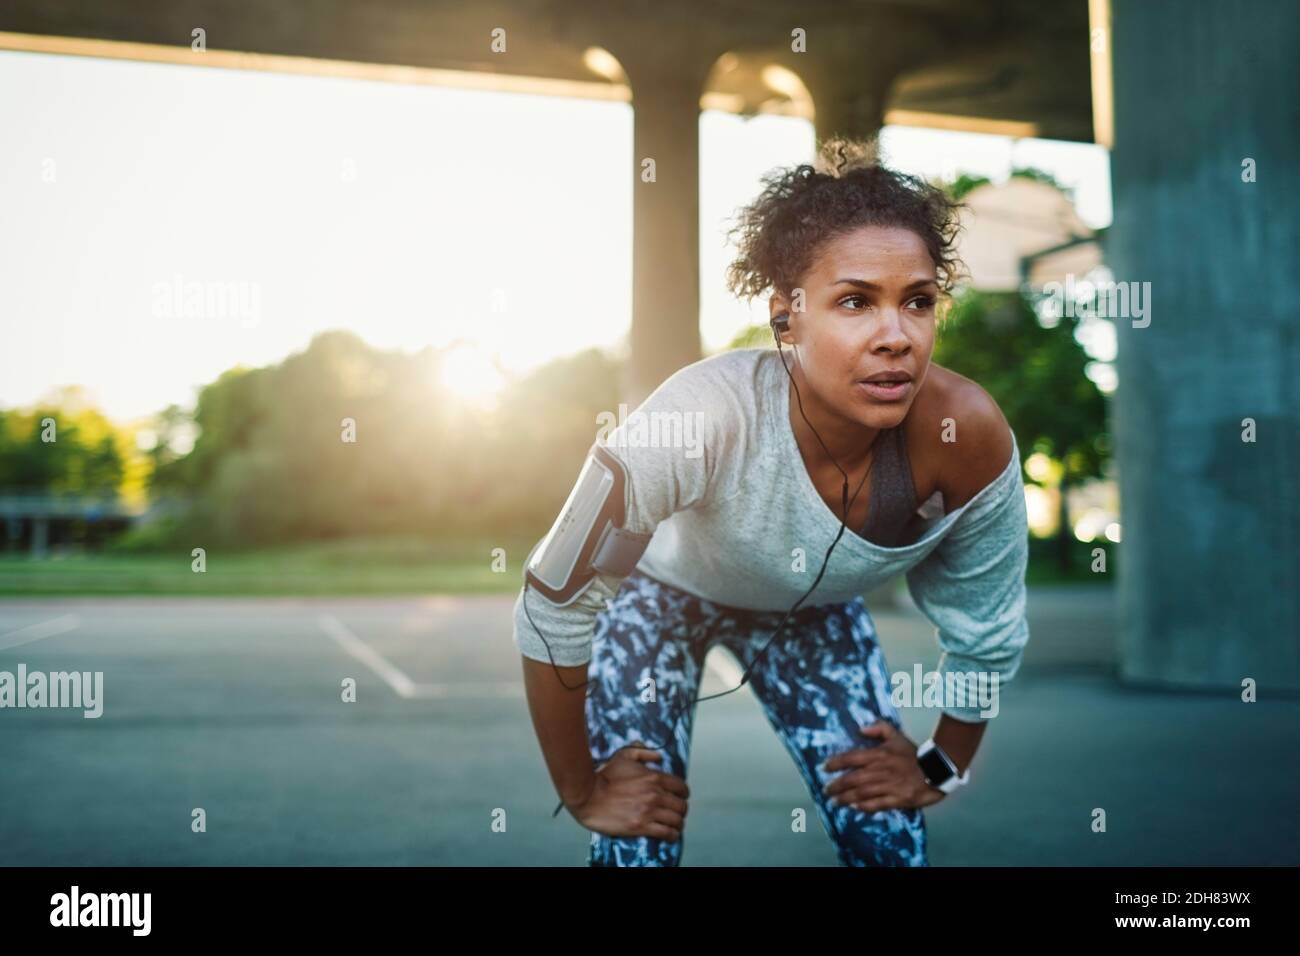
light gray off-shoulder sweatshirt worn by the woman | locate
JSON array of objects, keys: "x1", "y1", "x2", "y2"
[{"x1": 514, "y1": 349, "x2": 1030, "y2": 722}]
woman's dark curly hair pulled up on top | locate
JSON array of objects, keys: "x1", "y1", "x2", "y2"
[{"x1": 727, "y1": 137, "x2": 963, "y2": 299}]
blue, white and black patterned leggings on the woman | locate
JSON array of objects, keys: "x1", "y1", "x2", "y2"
[{"x1": 586, "y1": 571, "x2": 928, "y2": 866}]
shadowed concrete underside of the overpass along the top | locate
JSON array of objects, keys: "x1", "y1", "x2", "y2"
[{"x1": 0, "y1": 0, "x2": 1092, "y2": 142}]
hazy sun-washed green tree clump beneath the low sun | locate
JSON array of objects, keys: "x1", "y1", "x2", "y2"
[{"x1": 139, "y1": 332, "x2": 619, "y2": 546}]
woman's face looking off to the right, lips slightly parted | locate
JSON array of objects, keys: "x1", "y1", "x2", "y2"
[{"x1": 771, "y1": 226, "x2": 939, "y2": 428}]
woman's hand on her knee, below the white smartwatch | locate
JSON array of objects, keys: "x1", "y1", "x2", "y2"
[{"x1": 822, "y1": 721, "x2": 946, "y2": 813}]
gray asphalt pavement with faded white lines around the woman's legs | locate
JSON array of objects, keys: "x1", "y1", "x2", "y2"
[{"x1": 0, "y1": 588, "x2": 1300, "y2": 866}]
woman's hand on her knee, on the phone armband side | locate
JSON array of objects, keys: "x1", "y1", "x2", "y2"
[{"x1": 571, "y1": 747, "x2": 690, "y2": 843}]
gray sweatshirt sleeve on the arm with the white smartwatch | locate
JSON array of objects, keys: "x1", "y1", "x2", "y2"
[{"x1": 906, "y1": 441, "x2": 1030, "y2": 723}]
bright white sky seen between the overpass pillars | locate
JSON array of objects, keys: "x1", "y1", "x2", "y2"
[{"x1": 0, "y1": 51, "x2": 1110, "y2": 419}]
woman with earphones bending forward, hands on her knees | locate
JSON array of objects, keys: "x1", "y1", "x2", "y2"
[{"x1": 515, "y1": 139, "x2": 1028, "y2": 866}]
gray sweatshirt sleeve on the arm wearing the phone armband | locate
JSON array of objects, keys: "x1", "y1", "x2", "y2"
[{"x1": 514, "y1": 356, "x2": 748, "y2": 666}]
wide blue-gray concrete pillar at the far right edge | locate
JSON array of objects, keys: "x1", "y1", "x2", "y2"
[{"x1": 1106, "y1": 0, "x2": 1300, "y2": 697}]
